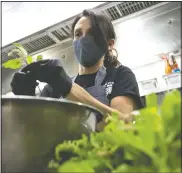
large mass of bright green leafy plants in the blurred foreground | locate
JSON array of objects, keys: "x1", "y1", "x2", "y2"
[{"x1": 49, "y1": 91, "x2": 181, "y2": 173}]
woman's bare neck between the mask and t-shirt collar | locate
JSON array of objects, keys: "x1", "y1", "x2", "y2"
[{"x1": 78, "y1": 60, "x2": 103, "y2": 75}]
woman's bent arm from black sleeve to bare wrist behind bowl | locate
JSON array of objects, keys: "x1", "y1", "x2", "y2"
[{"x1": 67, "y1": 66, "x2": 142, "y2": 122}]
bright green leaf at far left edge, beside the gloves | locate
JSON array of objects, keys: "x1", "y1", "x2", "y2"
[{"x1": 2, "y1": 58, "x2": 23, "y2": 69}]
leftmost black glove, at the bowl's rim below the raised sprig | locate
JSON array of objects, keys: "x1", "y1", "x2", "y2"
[{"x1": 10, "y1": 69, "x2": 38, "y2": 96}]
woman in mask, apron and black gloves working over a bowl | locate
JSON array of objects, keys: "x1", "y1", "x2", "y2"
[{"x1": 11, "y1": 10, "x2": 142, "y2": 121}]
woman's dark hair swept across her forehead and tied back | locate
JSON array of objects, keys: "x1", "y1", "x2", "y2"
[{"x1": 71, "y1": 10, "x2": 120, "y2": 68}]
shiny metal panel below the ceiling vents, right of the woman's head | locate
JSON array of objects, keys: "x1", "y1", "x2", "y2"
[{"x1": 114, "y1": 2, "x2": 181, "y2": 69}]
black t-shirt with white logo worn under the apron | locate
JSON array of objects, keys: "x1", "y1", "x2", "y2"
[{"x1": 75, "y1": 65, "x2": 143, "y2": 109}]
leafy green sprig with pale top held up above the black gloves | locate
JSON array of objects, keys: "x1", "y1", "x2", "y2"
[{"x1": 2, "y1": 43, "x2": 42, "y2": 69}]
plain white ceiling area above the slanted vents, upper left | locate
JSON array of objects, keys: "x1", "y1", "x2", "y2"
[{"x1": 2, "y1": 2, "x2": 104, "y2": 46}]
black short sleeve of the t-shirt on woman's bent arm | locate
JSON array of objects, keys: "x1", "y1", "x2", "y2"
[{"x1": 110, "y1": 66, "x2": 143, "y2": 109}]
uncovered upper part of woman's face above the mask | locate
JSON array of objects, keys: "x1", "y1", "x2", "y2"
[{"x1": 74, "y1": 16, "x2": 91, "y2": 40}]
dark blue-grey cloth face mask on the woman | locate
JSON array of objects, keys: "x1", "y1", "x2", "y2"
[{"x1": 73, "y1": 35, "x2": 104, "y2": 67}]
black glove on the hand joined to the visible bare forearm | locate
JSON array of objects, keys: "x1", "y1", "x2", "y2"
[{"x1": 21, "y1": 59, "x2": 72, "y2": 98}]
